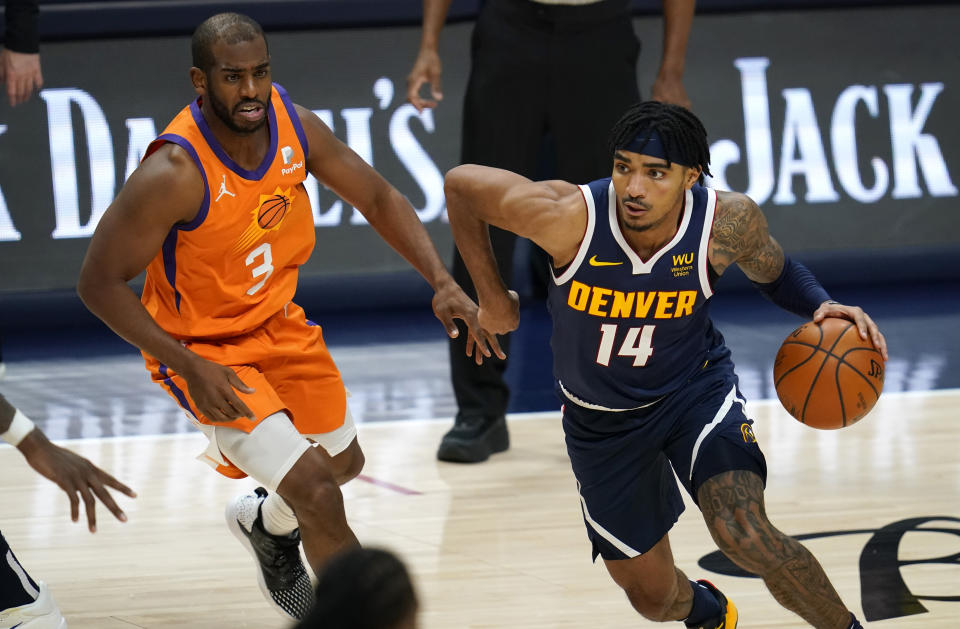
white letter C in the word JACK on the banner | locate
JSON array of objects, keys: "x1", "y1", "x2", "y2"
[{"x1": 830, "y1": 85, "x2": 890, "y2": 203}]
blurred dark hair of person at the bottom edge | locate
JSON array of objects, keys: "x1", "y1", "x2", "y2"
[{"x1": 296, "y1": 546, "x2": 418, "y2": 629}]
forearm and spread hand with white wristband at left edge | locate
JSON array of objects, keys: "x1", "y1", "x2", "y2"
[{"x1": 0, "y1": 395, "x2": 137, "y2": 533}]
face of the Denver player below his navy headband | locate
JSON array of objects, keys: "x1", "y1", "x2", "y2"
[{"x1": 612, "y1": 150, "x2": 699, "y2": 232}]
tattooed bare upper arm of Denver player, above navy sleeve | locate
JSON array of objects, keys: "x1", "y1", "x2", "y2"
[{"x1": 709, "y1": 191, "x2": 784, "y2": 283}]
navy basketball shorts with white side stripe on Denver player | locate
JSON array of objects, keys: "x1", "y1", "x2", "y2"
[{"x1": 563, "y1": 358, "x2": 767, "y2": 560}]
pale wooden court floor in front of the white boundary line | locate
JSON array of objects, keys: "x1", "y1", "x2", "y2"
[{"x1": 0, "y1": 389, "x2": 960, "y2": 629}]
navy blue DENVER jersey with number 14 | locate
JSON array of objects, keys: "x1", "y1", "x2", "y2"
[{"x1": 547, "y1": 177, "x2": 728, "y2": 410}]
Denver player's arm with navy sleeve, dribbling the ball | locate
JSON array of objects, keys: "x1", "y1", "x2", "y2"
[{"x1": 709, "y1": 192, "x2": 888, "y2": 359}]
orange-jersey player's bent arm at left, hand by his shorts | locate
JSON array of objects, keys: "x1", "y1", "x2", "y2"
[{"x1": 77, "y1": 144, "x2": 252, "y2": 422}]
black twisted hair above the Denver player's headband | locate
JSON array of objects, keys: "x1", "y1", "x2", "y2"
[{"x1": 608, "y1": 100, "x2": 710, "y2": 183}]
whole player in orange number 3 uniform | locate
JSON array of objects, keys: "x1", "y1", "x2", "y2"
[{"x1": 78, "y1": 13, "x2": 502, "y2": 618}]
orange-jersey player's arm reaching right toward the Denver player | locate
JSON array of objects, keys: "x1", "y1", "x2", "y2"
[{"x1": 297, "y1": 105, "x2": 506, "y2": 362}]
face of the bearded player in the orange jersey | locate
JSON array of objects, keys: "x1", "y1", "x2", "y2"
[{"x1": 203, "y1": 37, "x2": 271, "y2": 135}]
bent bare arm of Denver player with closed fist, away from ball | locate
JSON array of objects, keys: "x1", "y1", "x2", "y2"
[{"x1": 444, "y1": 164, "x2": 587, "y2": 334}]
